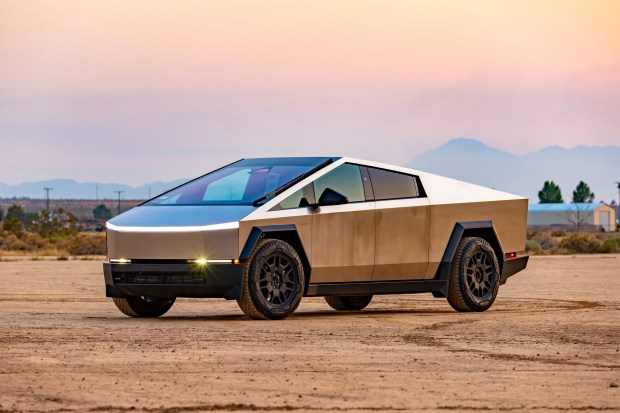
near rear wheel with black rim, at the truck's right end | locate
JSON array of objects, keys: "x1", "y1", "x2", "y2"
[{"x1": 448, "y1": 237, "x2": 500, "y2": 312}]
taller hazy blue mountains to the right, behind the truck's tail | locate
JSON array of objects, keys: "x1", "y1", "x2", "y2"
[{"x1": 407, "y1": 138, "x2": 620, "y2": 203}]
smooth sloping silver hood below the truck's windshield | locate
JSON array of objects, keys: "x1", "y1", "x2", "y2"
[{"x1": 107, "y1": 205, "x2": 256, "y2": 232}]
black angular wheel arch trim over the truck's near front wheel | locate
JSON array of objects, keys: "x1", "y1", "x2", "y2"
[{"x1": 239, "y1": 224, "x2": 312, "y2": 295}]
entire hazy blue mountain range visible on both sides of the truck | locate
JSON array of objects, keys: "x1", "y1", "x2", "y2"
[{"x1": 0, "y1": 138, "x2": 620, "y2": 203}]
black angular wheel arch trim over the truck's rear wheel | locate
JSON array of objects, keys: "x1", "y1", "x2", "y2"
[{"x1": 435, "y1": 221, "x2": 504, "y2": 297}]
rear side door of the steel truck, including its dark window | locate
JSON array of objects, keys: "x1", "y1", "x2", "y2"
[{"x1": 367, "y1": 167, "x2": 431, "y2": 281}]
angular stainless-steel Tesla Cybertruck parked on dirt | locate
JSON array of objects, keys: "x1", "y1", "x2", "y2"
[{"x1": 103, "y1": 157, "x2": 528, "y2": 319}]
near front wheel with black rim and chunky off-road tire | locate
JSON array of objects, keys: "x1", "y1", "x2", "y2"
[{"x1": 237, "y1": 239, "x2": 305, "y2": 320}]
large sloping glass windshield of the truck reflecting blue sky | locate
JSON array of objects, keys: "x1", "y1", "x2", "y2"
[{"x1": 145, "y1": 158, "x2": 330, "y2": 205}]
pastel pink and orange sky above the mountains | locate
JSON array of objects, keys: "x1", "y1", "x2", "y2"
[{"x1": 0, "y1": 0, "x2": 620, "y2": 185}]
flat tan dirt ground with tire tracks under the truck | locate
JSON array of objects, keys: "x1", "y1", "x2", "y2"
[{"x1": 0, "y1": 255, "x2": 620, "y2": 412}]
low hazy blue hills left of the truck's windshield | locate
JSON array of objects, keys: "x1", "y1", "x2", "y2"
[{"x1": 0, "y1": 179, "x2": 188, "y2": 199}]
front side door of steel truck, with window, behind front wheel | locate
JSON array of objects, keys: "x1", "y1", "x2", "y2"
[{"x1": 311, "y1": 164, "x2": 376, "y2": 283}]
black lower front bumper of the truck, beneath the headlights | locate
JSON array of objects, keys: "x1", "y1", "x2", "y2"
[{"x1": 103, "y1": 260, "x2": 245, "y2": 300}]
